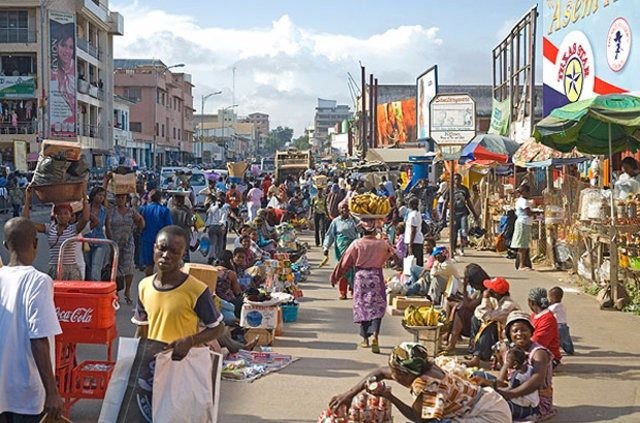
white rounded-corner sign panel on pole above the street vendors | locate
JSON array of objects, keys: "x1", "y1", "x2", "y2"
[{"x1": 429, "y1": 94, "x2": 476, "y2": 146}]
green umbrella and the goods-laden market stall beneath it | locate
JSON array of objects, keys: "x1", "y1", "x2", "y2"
[{"x1": 534, "y1": 94, "x2": 640, "y2": 308}]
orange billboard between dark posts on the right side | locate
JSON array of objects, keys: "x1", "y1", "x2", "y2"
[{"x1": 376, "y1": 98, "x2": 416, "y2": 146}]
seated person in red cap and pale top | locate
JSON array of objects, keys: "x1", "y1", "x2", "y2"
[{"x1": 466, "y1": 277, "x2": 520, "y2": 367}]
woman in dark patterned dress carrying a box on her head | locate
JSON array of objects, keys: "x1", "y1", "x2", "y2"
[{"x1": 105, "y1": 194, "x2": 144, "y2": 304}]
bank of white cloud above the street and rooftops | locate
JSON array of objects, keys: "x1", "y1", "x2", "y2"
[{"x1": 111, "y1": 1, "x2": 443, "y2": 134}]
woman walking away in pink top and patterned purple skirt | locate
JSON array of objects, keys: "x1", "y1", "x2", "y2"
[{"x1": 331, "y1": 220, "x2": 394, "y2": 353}]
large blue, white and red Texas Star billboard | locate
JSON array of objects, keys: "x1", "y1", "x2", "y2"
[{"x1": 542, "y1": 0, "x2": 640, "y2": 115}]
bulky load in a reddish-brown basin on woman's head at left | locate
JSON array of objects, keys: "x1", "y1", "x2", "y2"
[{"x1": 31, "y1": 140, "x2": 89, "y2": 204}]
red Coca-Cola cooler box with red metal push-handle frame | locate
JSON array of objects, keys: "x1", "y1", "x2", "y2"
[{"x1": 53, "y1": 238, "x2": 119, "y2": 333}]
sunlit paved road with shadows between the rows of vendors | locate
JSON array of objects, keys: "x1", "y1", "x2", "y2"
[{"x1": 0, "y1": 213, "x2": 640, "y2": 423}]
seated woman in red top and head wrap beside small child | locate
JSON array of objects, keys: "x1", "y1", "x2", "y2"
[{"x1": 528, "y1": 288, "x2": 562, "y2": 367}]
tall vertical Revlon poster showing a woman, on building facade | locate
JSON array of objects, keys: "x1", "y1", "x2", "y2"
[{"x1": 48, "y1": 11, "x2": 76, "y2": 138}]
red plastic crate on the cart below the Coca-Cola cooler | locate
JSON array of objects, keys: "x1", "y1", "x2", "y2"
[{"x1": 71, "y1": 361, "x2": 115, "y2": 399}]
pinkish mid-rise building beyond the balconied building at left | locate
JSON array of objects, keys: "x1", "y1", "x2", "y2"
[{"x1": 114, "y1": 59, "x2": 194, "y2": 168}]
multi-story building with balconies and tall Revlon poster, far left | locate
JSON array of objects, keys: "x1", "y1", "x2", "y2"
[{"x1": 0, "y1": 0, "x2": 124, "y2": 167}]
